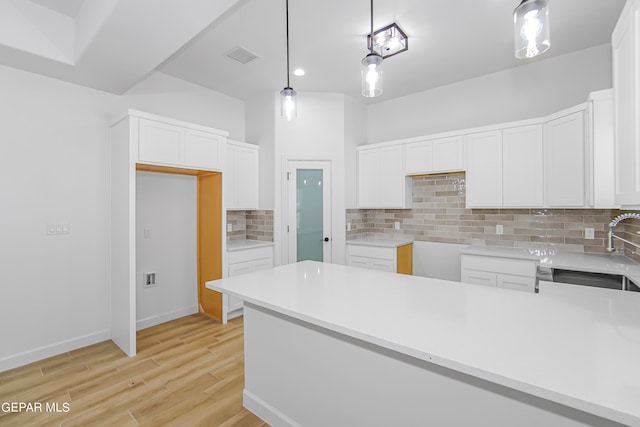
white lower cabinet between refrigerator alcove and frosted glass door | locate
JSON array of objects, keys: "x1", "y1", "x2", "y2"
[{"x1": 222, "y1": 246, "x2": 273, "y2": 323}]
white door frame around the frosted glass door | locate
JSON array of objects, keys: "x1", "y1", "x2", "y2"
[{"x1": 280, "y1": 154, "x2": 343, "y2": 264}]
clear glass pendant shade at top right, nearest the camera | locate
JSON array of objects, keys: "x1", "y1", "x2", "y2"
[{"x1": 513, "y1": 0, "x2": 551, "y2": 59}]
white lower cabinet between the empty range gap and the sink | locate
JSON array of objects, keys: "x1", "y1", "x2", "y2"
[{"x1": 460, "y1": 255, "x2": 538, "y2": 292}]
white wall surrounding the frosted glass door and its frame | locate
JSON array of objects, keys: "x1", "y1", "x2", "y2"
[{"x1": 272, "y1": 92, "x2": 346, "y2": 265}]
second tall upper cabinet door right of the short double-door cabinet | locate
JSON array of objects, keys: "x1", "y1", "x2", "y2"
[{"x1": 502, "y1": 125, "x2": 544, "y2": 207}]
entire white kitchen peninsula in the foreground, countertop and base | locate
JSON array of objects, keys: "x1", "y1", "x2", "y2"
[{"x1": 206, "y1": 261, "x2": 640, "y2": 427}]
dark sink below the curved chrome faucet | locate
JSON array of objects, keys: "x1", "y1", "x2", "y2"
[{"x1": 536, "y1": 266, "x2": 640, "y2": 292}]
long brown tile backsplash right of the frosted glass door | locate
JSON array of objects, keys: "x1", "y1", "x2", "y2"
[{"x1": 347, "y1": 174, "x2": 640, "y2": 260}]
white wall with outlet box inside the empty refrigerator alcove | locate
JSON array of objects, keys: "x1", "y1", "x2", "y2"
[{"x1": 136, "y1": 172, "x2": 198, "y2": 329}]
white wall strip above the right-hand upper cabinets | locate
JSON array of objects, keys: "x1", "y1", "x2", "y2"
[{"x1": 367, "y1": 44, "x2": 612, "y2": 143}]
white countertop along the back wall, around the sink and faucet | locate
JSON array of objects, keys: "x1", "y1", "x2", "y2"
[{"x1": 460, "y1": 246, "x2": 640, "y2": 282}]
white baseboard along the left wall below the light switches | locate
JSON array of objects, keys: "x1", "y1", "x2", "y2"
[{"x1": 0, "y1": 329, "x2": 111, "y2": 372}]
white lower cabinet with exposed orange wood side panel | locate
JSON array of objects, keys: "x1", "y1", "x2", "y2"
[{"x1": 347, "y1": 243, "x2": 413, "y2": 274}]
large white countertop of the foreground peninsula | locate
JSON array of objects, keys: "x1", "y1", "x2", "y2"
[{"x1": 206, "y1": 261, "x2": 640, "y2": 426}]
